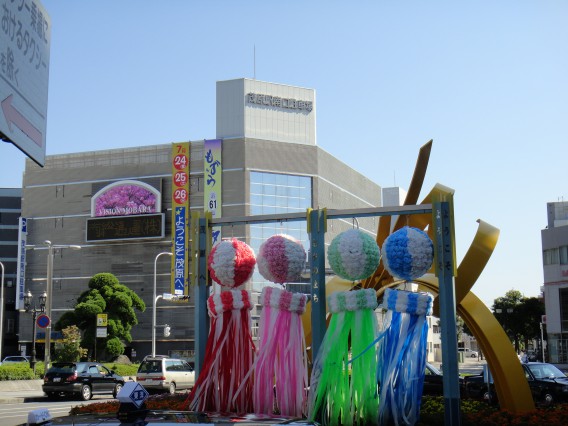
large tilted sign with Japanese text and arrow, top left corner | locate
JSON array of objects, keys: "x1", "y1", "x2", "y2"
[{"x1": 0, "y1": 0, "x2": 51, "y2": 166}]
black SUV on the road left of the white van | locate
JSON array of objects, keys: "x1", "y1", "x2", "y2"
[{"x1": 42, "y1": 362, "x2": 124, "y2": 401}]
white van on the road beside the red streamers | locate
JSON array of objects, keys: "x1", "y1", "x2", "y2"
[{"x1": 136, "y1": 355, "x2": 195, "y2": 394}]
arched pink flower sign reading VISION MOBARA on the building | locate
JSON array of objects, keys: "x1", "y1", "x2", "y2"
[{"x1": 91, "y1": 180, "x2": 162, "y2": 217}]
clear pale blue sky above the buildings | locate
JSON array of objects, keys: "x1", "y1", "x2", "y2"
[{"x1": 0, "y1": 0, "x2": 568, "y2": 305}]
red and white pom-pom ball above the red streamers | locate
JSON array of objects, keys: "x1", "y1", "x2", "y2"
[{"x1": 207, "y1": 238, "x2": 256, "y2": 288}]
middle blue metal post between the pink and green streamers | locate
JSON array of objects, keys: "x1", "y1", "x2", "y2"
[{"x1": 308, "y1": 209, "x2": 327, "y2": 362}]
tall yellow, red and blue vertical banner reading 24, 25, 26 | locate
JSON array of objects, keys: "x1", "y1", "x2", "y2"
[{"x1": 171, "y1": 142, "x2": 190, "y2": 296}]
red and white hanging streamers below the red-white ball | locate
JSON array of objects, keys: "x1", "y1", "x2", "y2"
[{"x1": 188, "y1": 290, "x2": 255, "y2": 413}]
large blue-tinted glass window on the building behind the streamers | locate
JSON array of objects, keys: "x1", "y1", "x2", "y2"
[{"x1": 250, "y1": 172, "x2": 312, "y2": 291}]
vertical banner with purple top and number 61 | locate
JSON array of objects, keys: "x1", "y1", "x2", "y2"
[{"x1": 203, "y1": 139, "x2": 223, "y2": 245}]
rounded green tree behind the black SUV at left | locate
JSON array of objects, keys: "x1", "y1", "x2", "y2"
[{"x1": 55, "y1": 273, "x2": 146, "y2": 358}]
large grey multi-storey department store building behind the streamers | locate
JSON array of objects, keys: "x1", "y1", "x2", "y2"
[{"x1": 18, "y1": 79, "x2": 382, "y2": 359}]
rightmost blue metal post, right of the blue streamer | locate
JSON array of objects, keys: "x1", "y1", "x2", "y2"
[{"x1": 432, "y1": 202, "x2": 461, "y2": 426}]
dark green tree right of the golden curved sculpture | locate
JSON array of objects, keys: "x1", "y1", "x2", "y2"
[{"x1": 493, "y1": 290, "x2": 544, "y2": 352}]
